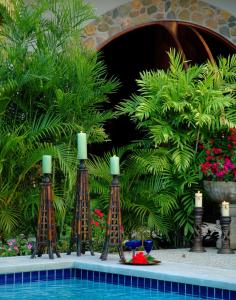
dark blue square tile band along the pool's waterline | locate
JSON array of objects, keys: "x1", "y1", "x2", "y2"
[{"x1": 0, "y1": 268, "x2": 236, "y2": 300}]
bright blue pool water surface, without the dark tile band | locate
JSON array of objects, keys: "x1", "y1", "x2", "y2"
[{"x1": 0, "y1": 279, "x2": 200, "y2": 300}]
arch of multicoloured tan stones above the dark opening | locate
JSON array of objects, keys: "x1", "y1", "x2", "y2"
[{"x1": 83, "y1": 0, "x2": 236, "y2": 50}]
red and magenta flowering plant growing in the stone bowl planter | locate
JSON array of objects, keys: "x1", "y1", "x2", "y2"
[{"x1": 199, "y1": 128, "x2": 236, "y2": 181}]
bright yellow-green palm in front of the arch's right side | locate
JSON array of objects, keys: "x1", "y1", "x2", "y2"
[{"x1": 117, "y1": 51, "x2": 236, "y2": 241}]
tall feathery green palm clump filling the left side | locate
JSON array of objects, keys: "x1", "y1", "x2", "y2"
[{"x1": 0, "y1": 0, "x2": 118, "y2": 238}]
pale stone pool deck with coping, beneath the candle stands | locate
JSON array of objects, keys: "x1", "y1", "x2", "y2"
[{"x1": 0, "y1": 249, "x2": 236, "y2": 292}]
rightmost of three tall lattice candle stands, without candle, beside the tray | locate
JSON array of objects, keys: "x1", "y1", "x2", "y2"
[{"x1": 100, "y1": 175, "x2": 125, "y2": 261}]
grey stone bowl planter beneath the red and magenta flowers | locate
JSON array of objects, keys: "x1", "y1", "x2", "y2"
[{"x1": 203, "y1": 180, "x2": 236, "y2": 204}]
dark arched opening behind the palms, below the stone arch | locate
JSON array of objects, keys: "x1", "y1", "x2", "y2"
[{"x1": 97, "y1": 21, "x2": 236, "y2": 150}]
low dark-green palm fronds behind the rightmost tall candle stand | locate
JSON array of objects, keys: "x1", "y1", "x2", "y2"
[{"x1": 88, "y1": 146, "x2": 176, "y2": 243}]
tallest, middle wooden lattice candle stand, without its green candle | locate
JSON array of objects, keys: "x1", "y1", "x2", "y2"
[{"x1": 67, "y1": 159, "x2": 94, "y2": 256}]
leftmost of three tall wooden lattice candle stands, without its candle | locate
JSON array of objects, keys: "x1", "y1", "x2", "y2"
[{"x1": 31, "y1": 174, "x2": 60, "y2": 259}]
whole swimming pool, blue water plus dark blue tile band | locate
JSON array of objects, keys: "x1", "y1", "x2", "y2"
[{"x1": 0, "y1": 268, "x2": 236, "y2": 300}]
